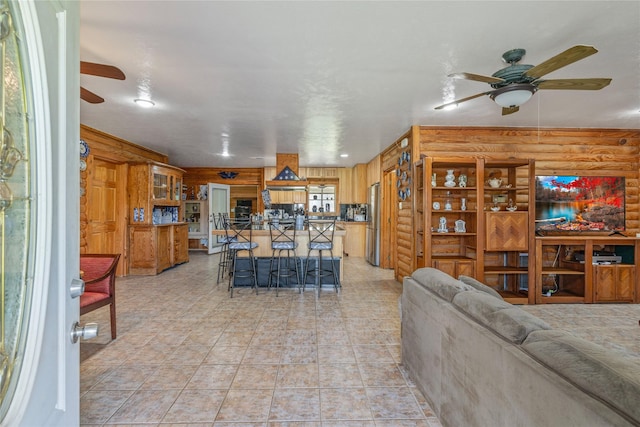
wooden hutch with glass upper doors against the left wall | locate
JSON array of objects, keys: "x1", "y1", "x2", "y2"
[{"x1": 128, "y1": 162, "x2": 189, "y2": 275}]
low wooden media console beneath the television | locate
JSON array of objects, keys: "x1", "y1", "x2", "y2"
[{"x1": 536, "y1": 235, "x2": 640, "y2": 304}]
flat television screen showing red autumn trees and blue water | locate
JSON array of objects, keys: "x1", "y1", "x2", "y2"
[{"x1": 535, "y1": 176, "x2": 625, "y2": 233}]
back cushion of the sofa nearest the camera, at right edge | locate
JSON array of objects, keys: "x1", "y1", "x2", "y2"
[{"x1": 522, "y1": 330, "x2": 640, "y2": 422}]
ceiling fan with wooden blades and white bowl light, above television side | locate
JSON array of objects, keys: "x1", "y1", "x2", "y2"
[{"x1": 435, "y1": 45, "x2": 611, "y2": 116}]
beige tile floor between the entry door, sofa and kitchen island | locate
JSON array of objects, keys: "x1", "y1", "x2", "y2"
[{"x1": 80, "y1": 253, "x2": 440, "y2": 427}]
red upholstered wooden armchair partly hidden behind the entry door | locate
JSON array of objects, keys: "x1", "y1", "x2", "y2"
[{"x1": 80, "y1": 254, "x2": 120, "y2": 339}]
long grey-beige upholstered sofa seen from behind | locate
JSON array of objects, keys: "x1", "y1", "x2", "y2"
[{"x1": 401, "y1": 268, "x2": 640, "y2": 427}]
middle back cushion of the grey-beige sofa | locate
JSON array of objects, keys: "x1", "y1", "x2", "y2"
[{"x1": 453, "y1": 289, "x2": 551, "y2": 344}]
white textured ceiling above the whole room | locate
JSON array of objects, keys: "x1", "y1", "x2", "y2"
[{"x1": 80, "y1": 0, "x2": 640, "y2": 167}]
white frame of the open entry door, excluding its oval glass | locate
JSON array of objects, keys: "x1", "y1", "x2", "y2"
[{"x1": 0, "y1": 0, "x2": 80, "y2": 426}]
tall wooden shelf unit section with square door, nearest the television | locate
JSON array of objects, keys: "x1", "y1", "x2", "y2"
[{"x1": 477, "y1": 160, "x2": 535, "y2": 304}]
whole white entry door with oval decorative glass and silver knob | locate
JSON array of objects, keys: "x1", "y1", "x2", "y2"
[{"x1": 0, "y1": 0, "x2": 82, "y2": 426}]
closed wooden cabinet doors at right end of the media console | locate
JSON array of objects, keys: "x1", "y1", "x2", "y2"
[{"x1": 593, "y1": 264, "x2": 636, "y2": 302}]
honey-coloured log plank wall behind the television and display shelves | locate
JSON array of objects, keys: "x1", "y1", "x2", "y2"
[{"x1": 383, "y1": 126, "x2": 640, "y2": 280}]
